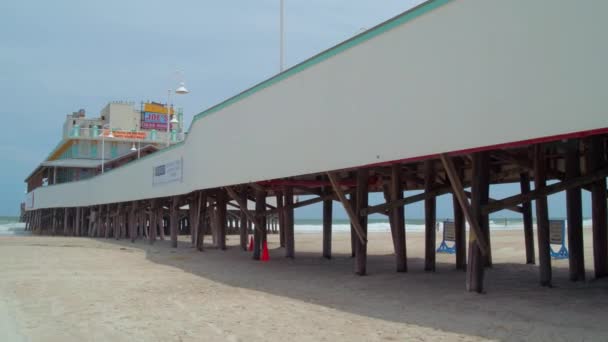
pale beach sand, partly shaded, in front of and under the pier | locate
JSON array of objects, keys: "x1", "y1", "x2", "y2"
[{"x1": 0, "y1": 230, "x2": 608, "y2": 342}]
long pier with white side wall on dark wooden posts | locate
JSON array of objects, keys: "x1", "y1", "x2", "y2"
[{"x1": 25, "y1": 0, "x2": 608, "y2": 292}]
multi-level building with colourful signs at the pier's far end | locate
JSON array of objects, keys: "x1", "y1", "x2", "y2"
[{"x1": 25, "y1": 101, "x2": 184, "y2": 192}]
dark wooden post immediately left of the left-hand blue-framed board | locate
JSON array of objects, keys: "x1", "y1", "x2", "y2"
[{"x1": 424, "y1": 159, "x2": 437, "y2": 272}]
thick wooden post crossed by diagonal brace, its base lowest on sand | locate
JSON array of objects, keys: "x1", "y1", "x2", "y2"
[{"x1": 467, "y1": 152, "x2": 490, "y2": 293}]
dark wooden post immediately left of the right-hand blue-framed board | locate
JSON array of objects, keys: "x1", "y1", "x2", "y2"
[{"x1": 534, "y1": 144, "x2": 551, "y2": 287}]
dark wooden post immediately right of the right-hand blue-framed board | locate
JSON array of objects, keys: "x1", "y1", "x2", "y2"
[{"x1": 564, "y1": 140, "x2": 585, "y2": 281}]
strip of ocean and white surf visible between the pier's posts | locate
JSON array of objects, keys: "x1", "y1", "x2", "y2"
[{"x1": 294, "y1": 217, "x2": 591, "y2": 233}]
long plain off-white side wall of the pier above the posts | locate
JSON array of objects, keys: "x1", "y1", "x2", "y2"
[{"x1": 27, "y1": 0, "x2": 608, "y2": 208}]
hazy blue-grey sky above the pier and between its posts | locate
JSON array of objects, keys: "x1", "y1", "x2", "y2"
[{"x1": 0, "y1": 0, "x2": 589, "y2": 218}]
